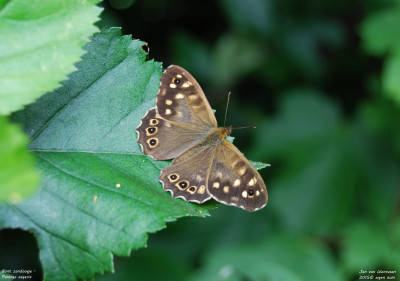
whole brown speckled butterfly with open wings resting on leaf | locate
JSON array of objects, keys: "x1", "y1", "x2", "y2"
[{"x1": 136, "y1": 65, "x2": 268, "y2": 211}]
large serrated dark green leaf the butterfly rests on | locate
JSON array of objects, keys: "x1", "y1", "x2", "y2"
[{"x1": 0, "y1": 28, "x2": 215, "y2": 280}]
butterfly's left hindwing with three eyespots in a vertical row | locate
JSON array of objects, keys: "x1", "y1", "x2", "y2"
[{"x1": 136, "y1": 108, "x2": 207, "y2": 160}]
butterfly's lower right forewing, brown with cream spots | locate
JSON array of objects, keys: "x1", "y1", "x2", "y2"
[{"x1": 207, "y1": 140, "x2": 268, "y2": 211}]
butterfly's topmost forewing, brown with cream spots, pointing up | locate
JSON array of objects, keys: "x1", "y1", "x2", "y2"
[{"x1": 156, "y1": 65, "x2": 217, "y2": 130}]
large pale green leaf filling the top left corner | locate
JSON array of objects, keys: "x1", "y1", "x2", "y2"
[{"x1": 0, "y1": 0, "x2": 102, "y2": 114}]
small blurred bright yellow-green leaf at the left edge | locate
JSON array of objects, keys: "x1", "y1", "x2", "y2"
[{"x1": 0, "y1": 116, "x2": 39, "y2": 203}]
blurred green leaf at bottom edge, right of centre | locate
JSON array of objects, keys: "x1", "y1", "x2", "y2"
[{"x1": 190, "y1": 233, "x2": 341, "y2": 281}]
